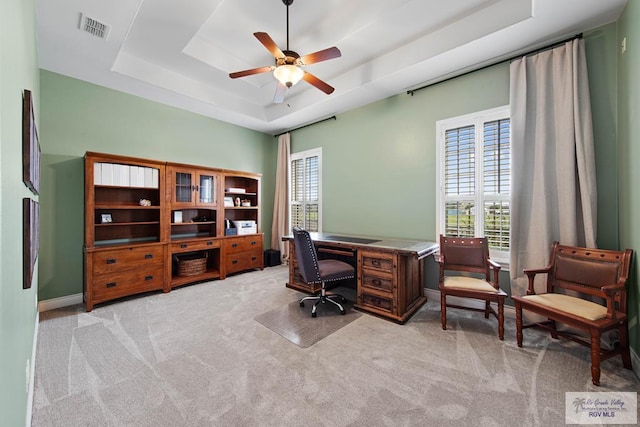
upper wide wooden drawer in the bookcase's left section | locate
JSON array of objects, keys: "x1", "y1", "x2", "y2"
[{"x1": 93, "y1": 246, "x2": 163, "y2": 275}]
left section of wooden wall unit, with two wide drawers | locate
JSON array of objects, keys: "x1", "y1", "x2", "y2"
[{"x1": 84, "y1": 153, "x2": 167, "y2": 311}]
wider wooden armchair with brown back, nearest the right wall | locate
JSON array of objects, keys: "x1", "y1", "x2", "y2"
[{"x1": 512, "y1": 242, "x2": 633, "y2": 385}]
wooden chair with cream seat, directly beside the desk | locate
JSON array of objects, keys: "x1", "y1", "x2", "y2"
[{"x1": 437, "y1": 235, "x2": 507, "y2": 340}]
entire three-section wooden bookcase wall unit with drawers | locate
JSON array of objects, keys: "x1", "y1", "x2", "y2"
[{"x1": 84, "y1": 152, "x2": 264, "y2": 311}]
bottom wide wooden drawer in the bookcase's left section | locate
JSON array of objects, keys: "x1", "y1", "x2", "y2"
[{"x1": 91, "y1": 265, "x2": 164, "y2": 302}]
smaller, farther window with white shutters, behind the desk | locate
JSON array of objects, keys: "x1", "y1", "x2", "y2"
[{"x1": 289, "y1": 148, "x2": 322, "y2": 231}]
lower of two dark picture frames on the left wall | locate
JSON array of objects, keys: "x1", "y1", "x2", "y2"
[{"x1": 22, "y1": 197, "x2": 40, "y2": 289}]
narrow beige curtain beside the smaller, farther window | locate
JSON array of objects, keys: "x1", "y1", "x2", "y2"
[{"x1": 271, "y1": 133, "x2": 291, "y2": 263}]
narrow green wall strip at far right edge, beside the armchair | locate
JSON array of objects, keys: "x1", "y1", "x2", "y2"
[{"x1": 612, "y1": 1, "x2": 640, "y2": 362}]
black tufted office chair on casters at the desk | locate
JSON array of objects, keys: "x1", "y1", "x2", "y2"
[{"x1": 293, "y1": 227, "x2": 355, "y2": 317}]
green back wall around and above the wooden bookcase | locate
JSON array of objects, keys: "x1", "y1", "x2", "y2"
[{"x1": 40, "y1": 71, "x2": 277, "y2": 300}]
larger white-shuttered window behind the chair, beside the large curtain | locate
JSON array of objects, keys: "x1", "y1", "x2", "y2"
[{"x1": 436, "y1": 106, "x2": 511, "y2": 263}]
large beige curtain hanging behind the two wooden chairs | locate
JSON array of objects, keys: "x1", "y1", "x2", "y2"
[{"x1": 510, "y1": 39, "x2": 596, "y2": 295}]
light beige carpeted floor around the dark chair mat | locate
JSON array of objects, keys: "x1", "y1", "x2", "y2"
[{"x1": 32, "y1": 266, "x2": 640, "y2": 427}]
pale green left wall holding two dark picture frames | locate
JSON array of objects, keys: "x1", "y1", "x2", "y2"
[{"x1": 0, "y1": 0, "x2": 40, "y2": 426}]
